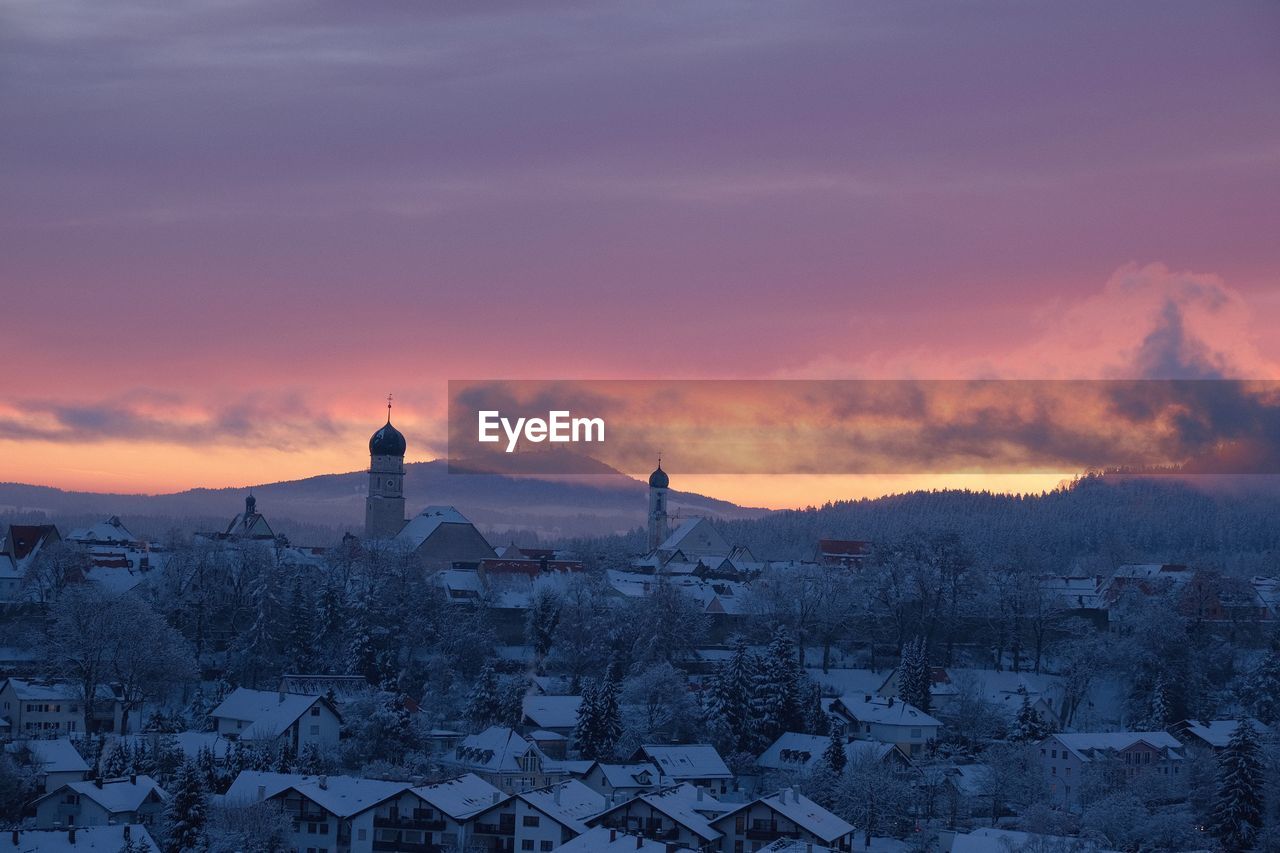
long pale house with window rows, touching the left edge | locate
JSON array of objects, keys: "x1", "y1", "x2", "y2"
[{"x1": 0, "y1": 678, "x2": 124, "y2": 738}]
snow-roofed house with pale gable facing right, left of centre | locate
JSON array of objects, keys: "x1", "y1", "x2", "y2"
[{"x1": 209, "y1": 688, "x2": 342, "y2": 754}]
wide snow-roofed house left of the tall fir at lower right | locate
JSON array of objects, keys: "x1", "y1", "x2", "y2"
[{"x1": 1038, "y1": 731, "x2": 1187, "y2": 808}]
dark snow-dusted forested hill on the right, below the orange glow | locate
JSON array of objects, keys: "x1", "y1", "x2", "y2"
[{"x1": 722, "y1": 476, "x2": 1280, "y2": 574}]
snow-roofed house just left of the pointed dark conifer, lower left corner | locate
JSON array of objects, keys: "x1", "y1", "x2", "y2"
[{"x1": 32, "y1": 775, "x2": 169, "y2": 829}]
